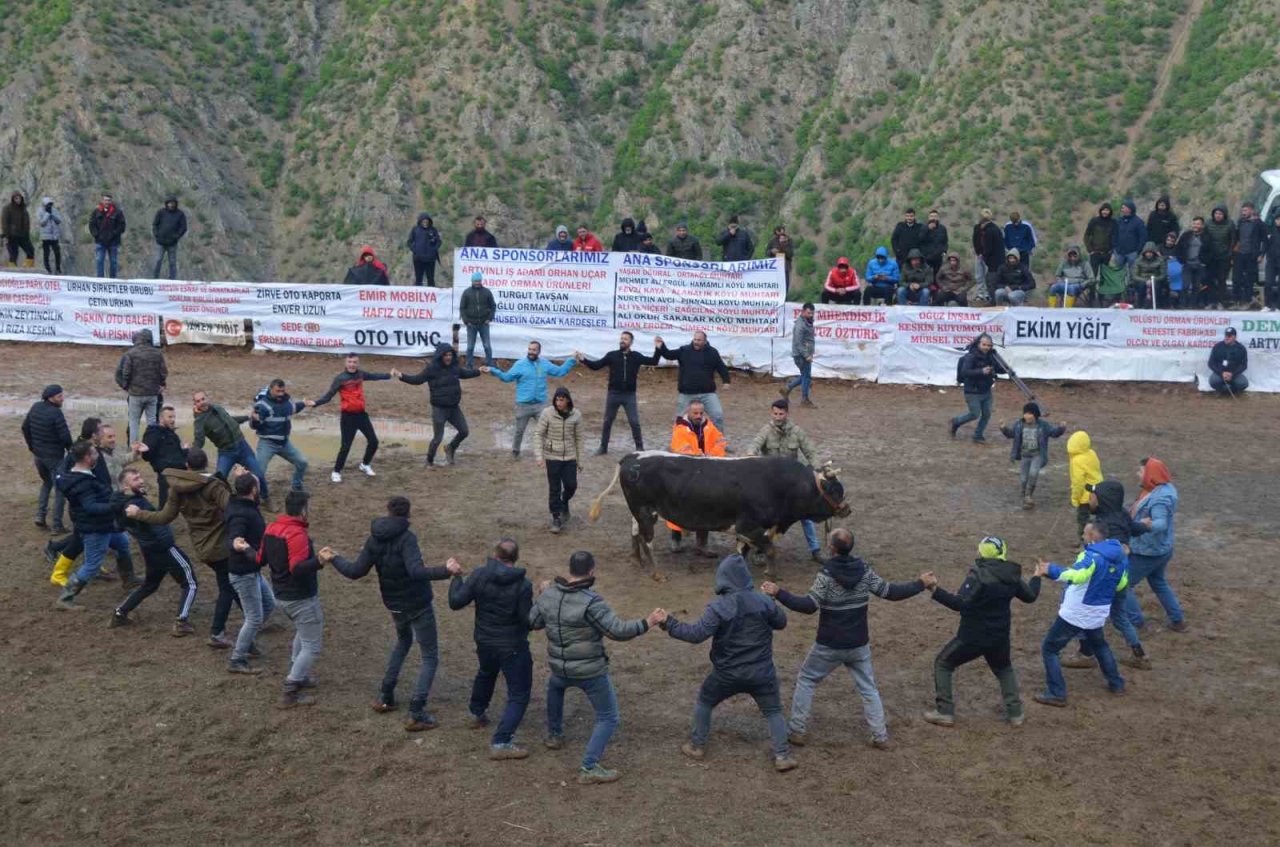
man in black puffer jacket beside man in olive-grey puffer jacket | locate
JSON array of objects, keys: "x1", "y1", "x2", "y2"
[{"x1": 449, "y1": 539, "x2": 534, "y2": 760}]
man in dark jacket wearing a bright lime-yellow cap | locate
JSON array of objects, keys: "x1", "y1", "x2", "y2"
[{"x1": 924, "y1": 536, "x2": 1041, "y2": 727}]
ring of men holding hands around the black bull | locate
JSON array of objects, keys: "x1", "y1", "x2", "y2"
[{"x1": 23, "y1": 312, "x2": 1182, "y2": 784}]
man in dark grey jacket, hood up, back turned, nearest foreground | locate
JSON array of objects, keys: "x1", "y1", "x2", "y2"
[{"x1": 659, "y1": 553, "x2": 797, "y2": 773}]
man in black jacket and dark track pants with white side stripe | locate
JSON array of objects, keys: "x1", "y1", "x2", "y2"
[{"x1": 111, "y1": 467, "x2": 198, "y2": 638}]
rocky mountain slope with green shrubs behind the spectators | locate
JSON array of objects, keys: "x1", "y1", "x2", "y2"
[{"x1": 0, "y1": 0, "x2": 1280, "y2": 298}]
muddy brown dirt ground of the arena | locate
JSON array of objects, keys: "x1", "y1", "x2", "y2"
[{"x1": 0, "y1": 345, "x2": 1280, "y2": 844}]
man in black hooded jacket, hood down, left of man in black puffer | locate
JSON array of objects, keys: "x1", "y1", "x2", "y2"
[{"x1": 333, "y1": 496, "x2": 462, "y2": 732}]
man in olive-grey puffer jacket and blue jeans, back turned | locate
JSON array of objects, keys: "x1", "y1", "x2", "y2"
[{"x1": 529, "y1": 550, "x2": 664, "y2": 786}]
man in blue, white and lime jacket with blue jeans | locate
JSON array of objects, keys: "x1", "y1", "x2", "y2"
[{"x1": 1034, "y1": 522, "x2": 1129, "y2": 708}]
